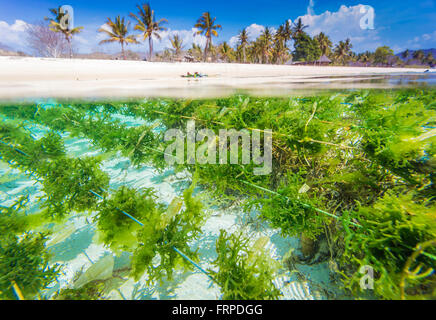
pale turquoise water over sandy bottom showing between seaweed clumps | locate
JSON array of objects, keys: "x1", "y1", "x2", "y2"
[{"x1": 0, "y1": 116, "x2": 335, "y2": 300}]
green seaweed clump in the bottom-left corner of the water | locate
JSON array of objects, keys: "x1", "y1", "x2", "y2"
[{"x1": 0, "y1": 233, "x2": 60, "y2": 299}]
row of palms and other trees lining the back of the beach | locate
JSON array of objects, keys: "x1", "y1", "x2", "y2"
[{"x1": 25, "y1": 3, "x2": 436, "y2": 66}]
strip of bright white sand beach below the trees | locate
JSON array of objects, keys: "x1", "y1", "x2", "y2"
[{"x1": 0, "y1": 57, "x2": 425, "y2": 100}]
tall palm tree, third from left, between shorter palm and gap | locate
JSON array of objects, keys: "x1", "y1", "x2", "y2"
[{"x1": 130, "y1": 3, "x2": 168, "y2": 61}]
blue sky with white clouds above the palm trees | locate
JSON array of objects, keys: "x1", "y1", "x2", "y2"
[{"x1": 0, "y1": 0, "x2": 436, "y2": 52}]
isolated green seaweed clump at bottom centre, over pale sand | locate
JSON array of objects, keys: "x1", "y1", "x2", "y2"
[{"x1": 210, "y1": 230, "x2": 280, "y2": 300}]
